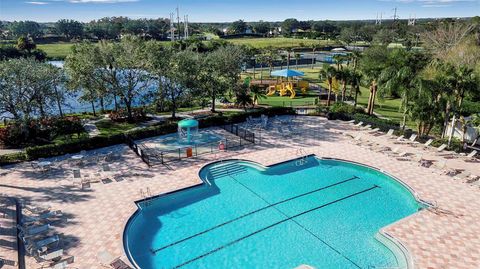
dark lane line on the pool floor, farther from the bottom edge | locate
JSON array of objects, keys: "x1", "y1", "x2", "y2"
[{"x1": 150, "y1": 176, "x2": 359, "y2": 255}]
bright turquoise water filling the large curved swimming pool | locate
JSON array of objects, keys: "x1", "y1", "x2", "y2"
[{"x1": 124, "y1": 157, "x2": 421, "y2": 269}]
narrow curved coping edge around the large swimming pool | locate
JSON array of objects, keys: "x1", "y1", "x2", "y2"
[{"x1": 122, "y1": 154, "x2": 433, "y2": 269}]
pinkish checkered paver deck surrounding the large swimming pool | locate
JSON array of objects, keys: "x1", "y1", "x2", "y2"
[{"x1": 0, "y1": 117, "x2": 480, "y2": 269}]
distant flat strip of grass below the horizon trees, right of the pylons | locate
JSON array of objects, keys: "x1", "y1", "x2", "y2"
[{"x1": 225, "y1": 37, "x2": 338, "y2": 49}]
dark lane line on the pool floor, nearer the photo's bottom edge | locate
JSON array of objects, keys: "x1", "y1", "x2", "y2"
[{"x1": 173, "y1": 185, "x2": 380, "y2": 268}]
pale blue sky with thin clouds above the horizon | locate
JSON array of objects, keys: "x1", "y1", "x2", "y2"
[{"x1": 0, "y1": 0, "x2": 480, "y2": 22}]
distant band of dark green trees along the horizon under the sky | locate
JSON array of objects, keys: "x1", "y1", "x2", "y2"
[{"x1": 0, "y1": 16, "x2": 480, "y2": 44}]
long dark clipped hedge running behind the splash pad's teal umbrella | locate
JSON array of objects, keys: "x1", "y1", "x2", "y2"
[{"x1": 6, "y1": 107, "x2": 295, "y2": 161}]
